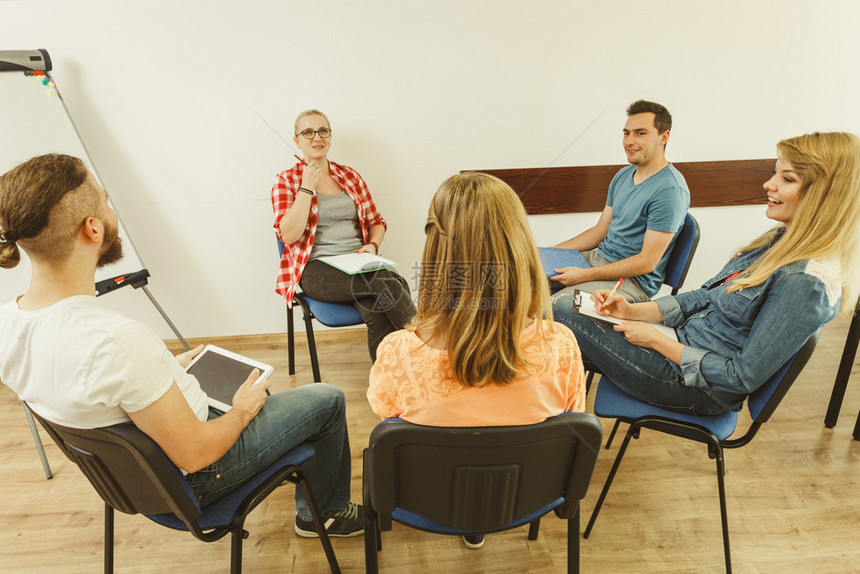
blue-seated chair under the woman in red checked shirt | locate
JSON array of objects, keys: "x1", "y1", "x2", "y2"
[{"x1": 278, "y1": 239, "x2": 364, "y2": 382}]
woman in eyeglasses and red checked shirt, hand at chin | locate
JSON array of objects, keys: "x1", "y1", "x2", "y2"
[{"x1": 272, "y1": 110, "x2": 415, "y2": 361}]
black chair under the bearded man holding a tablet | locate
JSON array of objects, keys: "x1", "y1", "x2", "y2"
[{"x1": 28, "y1": 412, "x2": 340, "y2": 574}]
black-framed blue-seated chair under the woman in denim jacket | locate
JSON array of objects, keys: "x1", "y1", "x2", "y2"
[{"x1": 583, "y1": 333, "x2": 818, "y2": 573}]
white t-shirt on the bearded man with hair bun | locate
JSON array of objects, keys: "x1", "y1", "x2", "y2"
[{"x1": 0, "y1": 295, "x2": 209, "y2": 428}]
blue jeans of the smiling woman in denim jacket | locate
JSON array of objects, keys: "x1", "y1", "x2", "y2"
[{"x1": 552, "y1": 295, "x2": 727, "y2": 415}]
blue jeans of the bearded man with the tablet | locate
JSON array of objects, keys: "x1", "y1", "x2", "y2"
[{"x1": 185, "y1": 383, "x2": 352, "y2": 522}]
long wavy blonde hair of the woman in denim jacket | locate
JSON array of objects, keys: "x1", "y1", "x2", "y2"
[{"x1": 727, "y1": 132, "x2": 860, "y2": 313}]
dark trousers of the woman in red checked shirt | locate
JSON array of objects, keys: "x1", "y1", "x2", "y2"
[{"x1": 299, "y1": 261, "x2": 415, "y2": 362}]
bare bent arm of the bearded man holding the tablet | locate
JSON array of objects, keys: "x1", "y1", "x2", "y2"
[{"x1": 128, "y1": 369, "x2": 270, "y2": 472}]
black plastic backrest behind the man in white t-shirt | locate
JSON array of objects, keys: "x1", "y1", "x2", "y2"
[{"x1": 28, "y1": 412, "x2": 200, "y2": 528}]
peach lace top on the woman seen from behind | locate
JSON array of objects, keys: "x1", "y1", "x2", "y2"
[{"x1": 367, "y1": 323, "x2": 585, "y2": 427}]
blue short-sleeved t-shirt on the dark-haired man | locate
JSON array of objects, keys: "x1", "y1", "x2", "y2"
[{"x1": 597, "y1": 164, "x2": 690, "y2": 297}]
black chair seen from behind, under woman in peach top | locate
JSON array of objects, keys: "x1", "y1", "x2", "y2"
[{"x1": 363, "y1": 413, "x2": 603, "y2": 572}]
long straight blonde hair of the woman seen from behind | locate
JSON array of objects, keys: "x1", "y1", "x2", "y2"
[{"x1": 409, "y1": 173, "x2": 552, "y2": 387}]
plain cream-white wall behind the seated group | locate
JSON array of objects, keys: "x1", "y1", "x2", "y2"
[{"x1": 0, "y1": 0, "x2": 860, "y2": 338}]
